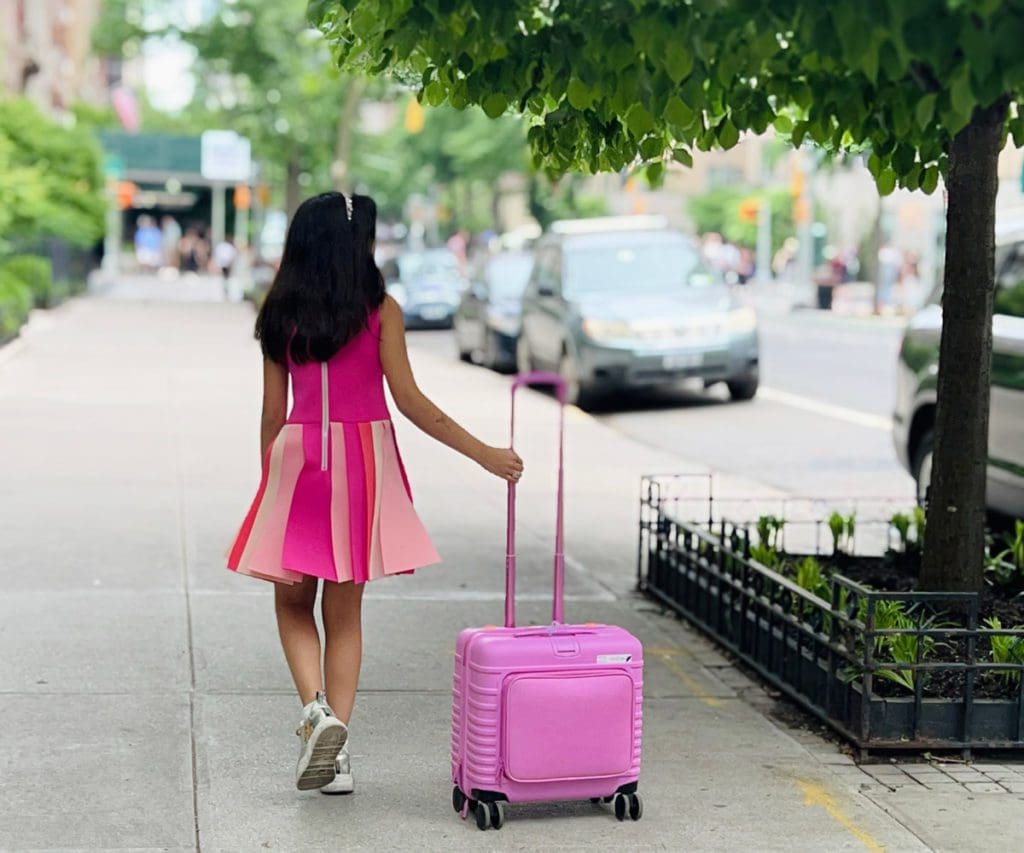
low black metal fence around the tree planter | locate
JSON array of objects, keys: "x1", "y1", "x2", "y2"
[{"x1": 637, "y1": 475, "x2": 1024, "y2": 755}]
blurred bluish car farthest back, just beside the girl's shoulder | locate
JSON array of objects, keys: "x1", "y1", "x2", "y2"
[{"x1": 382, "y1": 249, "x2": 468, "y2": 329}]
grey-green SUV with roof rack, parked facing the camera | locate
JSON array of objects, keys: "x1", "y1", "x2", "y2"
[{"x1": 516, "y1": 216, "x2": 759, "y2": 404}]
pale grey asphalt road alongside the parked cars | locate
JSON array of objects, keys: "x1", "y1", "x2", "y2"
[{"x1": 411, "y1": 311, "x2": 913, "y2": 503}]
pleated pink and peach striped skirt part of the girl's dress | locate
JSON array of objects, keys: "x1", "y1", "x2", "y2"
[{"x1": 227, "y1": 420, "x2": 440, "y2": 584}]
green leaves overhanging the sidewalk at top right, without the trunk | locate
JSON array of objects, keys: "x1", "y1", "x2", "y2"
[{"x1": 309, "y1": 0, "x2": 1024, "y2": 193}]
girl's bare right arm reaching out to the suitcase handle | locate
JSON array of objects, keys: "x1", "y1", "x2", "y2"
[{"x1": 381, "y1": 296, "x2": 522, "y2": 480}]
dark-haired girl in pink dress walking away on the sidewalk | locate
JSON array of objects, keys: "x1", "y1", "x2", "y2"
[{"x1": 228, "y1": 193, "x2": 522, "y2": 794}]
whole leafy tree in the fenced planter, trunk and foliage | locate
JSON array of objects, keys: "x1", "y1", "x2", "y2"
[{"x1": 308, "y1": 0, "x2": 1024, "y2": 589}]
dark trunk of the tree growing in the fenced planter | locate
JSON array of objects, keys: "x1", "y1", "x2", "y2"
[{"x1": 921, "y1": 100, "x2": 1007, "y2": 591}]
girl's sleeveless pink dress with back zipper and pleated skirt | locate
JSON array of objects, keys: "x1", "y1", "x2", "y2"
[{"x1": 227, "y1": 310, "x2": 440, "y2": 584}]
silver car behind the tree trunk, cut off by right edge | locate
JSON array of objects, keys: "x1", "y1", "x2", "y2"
[{"x1": 893, "y1": 227, "x2": 1024, "y2": 517}]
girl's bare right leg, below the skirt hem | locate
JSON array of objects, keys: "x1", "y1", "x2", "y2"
[{"x1": 322, "y1": 582, "x2": 366, "y2": 724}]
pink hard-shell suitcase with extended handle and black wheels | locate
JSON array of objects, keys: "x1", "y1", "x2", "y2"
[{"x1": 452, "y1": 373, "x2": 643, "y2": 829}]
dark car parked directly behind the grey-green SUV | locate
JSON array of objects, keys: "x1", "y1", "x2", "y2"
[{"x1": 455, "y1": 252, "x2": 534, "y2": 371}]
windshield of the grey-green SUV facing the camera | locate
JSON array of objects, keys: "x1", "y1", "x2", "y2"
[{"x1": 565, "y1": 238, "x2": 720, "y2": 298}]
